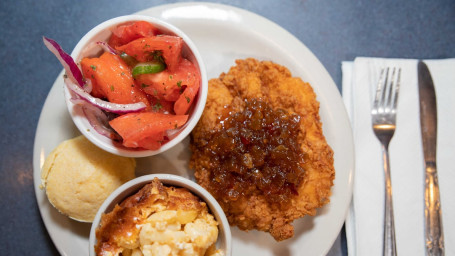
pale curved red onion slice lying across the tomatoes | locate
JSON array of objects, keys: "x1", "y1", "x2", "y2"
[{"x1": 65, "y1": 79, "x2": 146, "y2": 114}]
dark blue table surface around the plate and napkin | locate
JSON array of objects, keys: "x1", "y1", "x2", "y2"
[{"x1": 0, "y1": 0, "x2": 455, "y2": 255}]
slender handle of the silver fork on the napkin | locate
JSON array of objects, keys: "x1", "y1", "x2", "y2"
[{"x1": 382, "y1": 145, "x2": 397, "y2": 256}]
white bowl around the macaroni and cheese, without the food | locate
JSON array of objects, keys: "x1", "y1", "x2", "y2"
[{"x1": 89, "y1": 174, "x2": 232, "y2": 256}]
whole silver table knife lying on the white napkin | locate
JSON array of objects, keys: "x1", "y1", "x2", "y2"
[{"x1": 417, "y1": 61, "x2": 444, "y2": 256}]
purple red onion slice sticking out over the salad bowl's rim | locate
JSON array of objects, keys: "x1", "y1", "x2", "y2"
[{"x1": 43, "y1": 36, "x2": 84, "y2": 87}]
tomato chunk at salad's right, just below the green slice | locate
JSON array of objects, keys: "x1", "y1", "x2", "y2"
[{"x1": 136, "y1": 58, "x2": 200, "y2": 101}]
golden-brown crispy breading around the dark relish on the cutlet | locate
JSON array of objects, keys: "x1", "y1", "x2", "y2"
[{"x1": 190, "y1": 58, "x2": 335, "y2": 241}]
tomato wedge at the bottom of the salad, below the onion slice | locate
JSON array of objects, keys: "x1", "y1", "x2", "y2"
[{"x1": 109, "y1": 112, "x2": 188, "y2": 150}]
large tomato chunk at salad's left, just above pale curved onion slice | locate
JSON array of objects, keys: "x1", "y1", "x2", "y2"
[{"x1": 81, "y1": 52, "x2": 150, "y2": 106}]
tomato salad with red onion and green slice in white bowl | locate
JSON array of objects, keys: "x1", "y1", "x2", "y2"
[{"x1": 43, "y1": 21, "x2": 201, "y2": 150}]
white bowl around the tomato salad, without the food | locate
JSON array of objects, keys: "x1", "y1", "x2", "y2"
[{"x1": 64, "y1": 15, "x2": 208, "y2": 157}]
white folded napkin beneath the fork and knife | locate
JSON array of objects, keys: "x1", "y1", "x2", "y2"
[{"x1": 342, "y1": 58, "x2": 455, "y2": 256}]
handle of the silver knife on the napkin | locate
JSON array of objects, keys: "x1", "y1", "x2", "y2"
[{"x1": 425, "y1": 162, "x2": 444, "y2": 256}]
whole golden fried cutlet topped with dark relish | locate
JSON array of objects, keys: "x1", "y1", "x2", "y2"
[{"x1": 190, "y1": 58, "x2": 335, "y2": 241}]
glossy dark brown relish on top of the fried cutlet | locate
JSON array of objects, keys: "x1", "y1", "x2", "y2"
[{"x1": 196, "y1": 99, "x2": 304, "y2": 204}]
